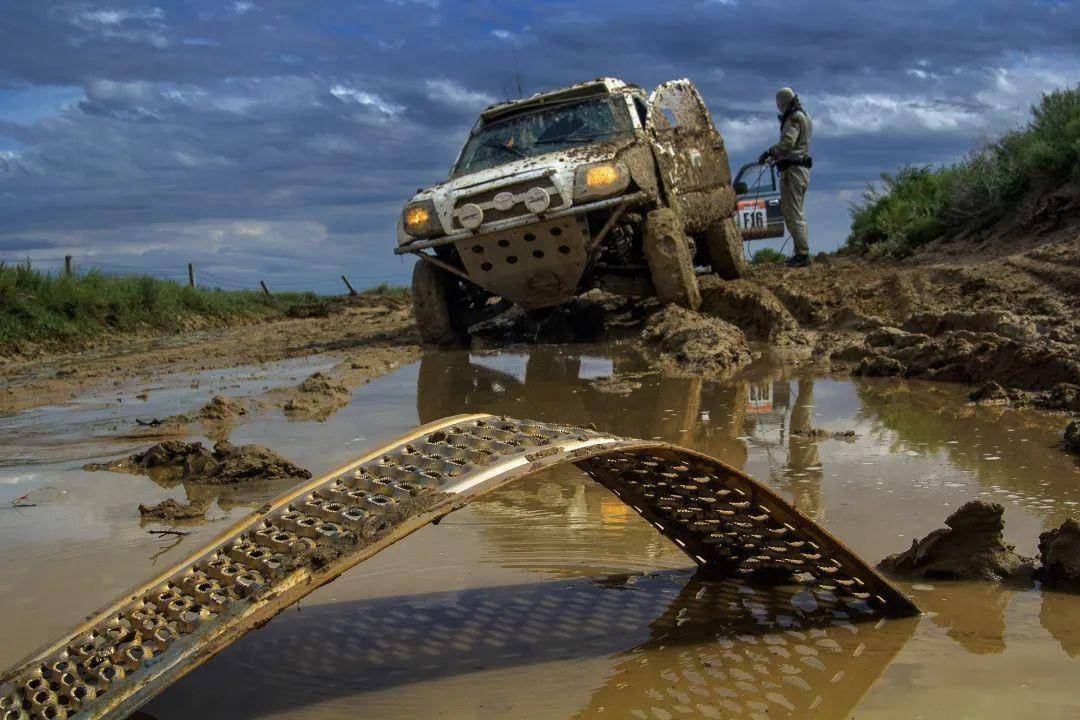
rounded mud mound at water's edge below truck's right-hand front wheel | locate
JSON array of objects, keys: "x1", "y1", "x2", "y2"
[{"x1": 642, "y1": 305, "x2": 752, "y2": 376}]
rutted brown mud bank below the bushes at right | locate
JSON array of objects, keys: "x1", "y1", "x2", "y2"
[{"x1": 751, "y1": 227, "x2": 1080, "y2": 412}]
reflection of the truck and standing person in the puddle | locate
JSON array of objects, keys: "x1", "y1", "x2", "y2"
[{"x1": 417, "y1": 345, "x2": 822, "y2": 517}]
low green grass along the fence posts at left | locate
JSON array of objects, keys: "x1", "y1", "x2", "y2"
[{"x1": 0, "y1": 262, "x2": 407, "y2": 355}]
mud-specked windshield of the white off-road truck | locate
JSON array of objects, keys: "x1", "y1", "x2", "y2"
[{"x1": 453, "y1": 95, "x2": 634, "y2": 177}]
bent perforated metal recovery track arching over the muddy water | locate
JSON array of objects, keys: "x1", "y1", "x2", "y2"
[{"x1": 0, "y1": 416, "x2": 918, "y2": 720}]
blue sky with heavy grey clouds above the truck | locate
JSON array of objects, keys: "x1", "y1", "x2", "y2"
[{"x1": 0, "y1": 0, "x2": 1080, "y2": 291}]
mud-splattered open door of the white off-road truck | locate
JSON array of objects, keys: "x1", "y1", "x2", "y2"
[{"x1": 647, "y1": 79, "x2": 734, "y2": 231}]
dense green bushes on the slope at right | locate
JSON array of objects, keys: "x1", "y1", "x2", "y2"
[{"x1": 847, "y1": 86, "x2": 1080, "y2": 257}]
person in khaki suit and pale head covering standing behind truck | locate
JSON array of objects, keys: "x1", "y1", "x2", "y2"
[{"x1": 758, "y1": 87, "x2": 813, "y2": 268}]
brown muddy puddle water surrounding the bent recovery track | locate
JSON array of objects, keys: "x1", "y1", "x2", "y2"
[{"x1": 0, "y1": 348, "x2": 1080, "y2": 720}]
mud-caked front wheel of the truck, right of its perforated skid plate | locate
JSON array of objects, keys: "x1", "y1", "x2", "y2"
[{"x1": 643, "y1": 207, "x2": 701, "y2": 310}]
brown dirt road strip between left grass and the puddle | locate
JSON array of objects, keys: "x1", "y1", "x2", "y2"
[{"x1": 0, "y1": 296, "x2": 419, "y2": 415}]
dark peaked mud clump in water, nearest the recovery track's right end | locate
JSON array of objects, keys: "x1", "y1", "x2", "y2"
[{"x1": 878, "y1": 500, "x2": 1030, "y2": 581}]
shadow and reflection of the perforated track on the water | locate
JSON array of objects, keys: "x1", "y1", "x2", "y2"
[{"x1": 146, "y1": 571, "x2": 918, "y2": 720}]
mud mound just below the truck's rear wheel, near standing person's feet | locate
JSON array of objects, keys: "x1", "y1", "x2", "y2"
[{"x1": 700, "y1": 275, "x2": 800, "y2": 345}]
